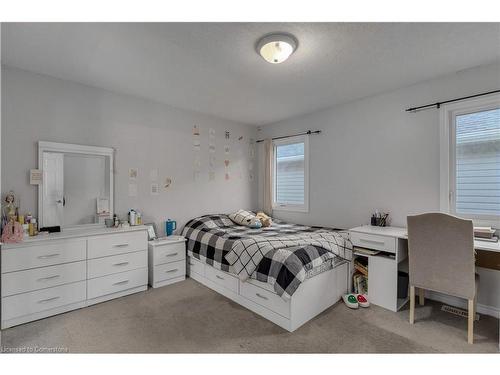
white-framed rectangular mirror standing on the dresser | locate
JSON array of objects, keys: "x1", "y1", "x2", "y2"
[{"x1": 38, "y1": 142, "x2": 113, "y2": 228}]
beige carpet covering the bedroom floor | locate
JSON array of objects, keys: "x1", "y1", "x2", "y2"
[{"x1": 1, "y1": 279, "x2": 498, "y2": 353}]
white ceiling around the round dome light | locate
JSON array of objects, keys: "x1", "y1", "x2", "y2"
[{"x1": 2, "y1": 23, "x2": 500, "y2": 125}]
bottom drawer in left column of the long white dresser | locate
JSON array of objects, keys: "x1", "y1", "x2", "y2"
[{"x1": 2, "y1": 281, "x2": 86, "y2": 320}]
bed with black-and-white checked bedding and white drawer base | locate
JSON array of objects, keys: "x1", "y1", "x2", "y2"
[{"x1": 182, "y1": 215, "x2": 352, "y2": 331}]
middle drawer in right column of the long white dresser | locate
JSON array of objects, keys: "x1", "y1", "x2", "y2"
[{"x1": 87, "y1": 250, "x2": 148, "y2": 279}]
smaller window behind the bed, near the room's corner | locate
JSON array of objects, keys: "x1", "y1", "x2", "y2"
[{"x1": 273, "y1": 136, "x2": 309, "y2": 212}]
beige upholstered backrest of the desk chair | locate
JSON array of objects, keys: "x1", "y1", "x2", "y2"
[{"x1": 407, "y1": 213, "x2": 475, "y2": 299}]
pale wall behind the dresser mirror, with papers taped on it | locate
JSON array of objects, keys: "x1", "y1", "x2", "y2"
[{"x1": 1, "y1": 67, "x2": 256, "y2": 235}]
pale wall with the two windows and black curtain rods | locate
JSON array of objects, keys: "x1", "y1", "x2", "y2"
[{"x1": 258, "y1": 65, "x2": 500, "y2": 228}]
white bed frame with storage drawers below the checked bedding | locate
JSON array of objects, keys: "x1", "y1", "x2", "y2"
[{"x1": 187, "y1": 257, "x2": 349, "y2": 332}]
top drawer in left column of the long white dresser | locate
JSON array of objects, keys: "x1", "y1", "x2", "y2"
[{"x1": 2, "y1": 239, "x2": 87, "y2": 273}]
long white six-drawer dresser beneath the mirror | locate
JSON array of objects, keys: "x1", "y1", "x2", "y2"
[{"x1": 0, "y1": 226, "x2": 148, "y2": 328}]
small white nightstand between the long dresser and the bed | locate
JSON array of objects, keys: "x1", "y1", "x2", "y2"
[{"x1": 148, "y1": 236, "x2": 186, "y2": 288}]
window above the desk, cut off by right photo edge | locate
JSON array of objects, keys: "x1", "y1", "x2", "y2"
[{"x1": 441, "y1": 96, "x2": 500, "y2": 227}]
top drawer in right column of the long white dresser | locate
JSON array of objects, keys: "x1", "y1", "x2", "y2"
[{"x1": 87, "y1": 230, "x2": 148, "y2": 259}]
